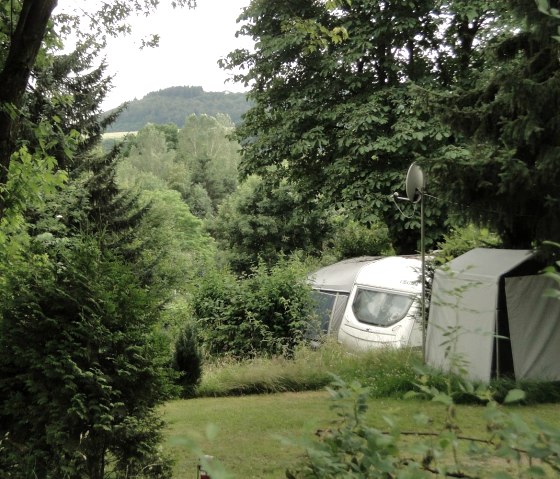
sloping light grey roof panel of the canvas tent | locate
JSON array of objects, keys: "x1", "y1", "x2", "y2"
[{"x1": 446, "y1": 248, "x2": 534, "y2": 279}]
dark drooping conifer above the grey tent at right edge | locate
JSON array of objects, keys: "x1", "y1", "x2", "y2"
[{"x1": 432, "y1": 0, "x2": 560, "y2": 248}]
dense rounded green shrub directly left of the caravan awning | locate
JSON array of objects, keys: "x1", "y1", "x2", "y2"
[{"x1": 193, "y1": 260, "x2": 313, "y2": 358}]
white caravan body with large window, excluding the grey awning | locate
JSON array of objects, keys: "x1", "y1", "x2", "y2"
[{"x1": 338, "y1": 256, "x2": 422, "y2": 351}]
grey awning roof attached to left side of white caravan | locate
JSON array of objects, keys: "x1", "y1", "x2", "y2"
[{"x1": 308, "y1": 256, "x2": 381, "y2": 293}]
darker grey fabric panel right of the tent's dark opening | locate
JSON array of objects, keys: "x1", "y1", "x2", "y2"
[{"x1": 505, "y1": 276, "x2": 560, "y2": 381}]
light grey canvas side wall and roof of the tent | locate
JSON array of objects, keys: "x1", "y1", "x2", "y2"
[{"x1": 426, "y1": 248, "x2": 533, "y2": 382}]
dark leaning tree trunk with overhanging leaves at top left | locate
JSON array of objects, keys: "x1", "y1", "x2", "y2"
[{"x1": 0, "y1": 0, "x2": 194, "y2": 219}]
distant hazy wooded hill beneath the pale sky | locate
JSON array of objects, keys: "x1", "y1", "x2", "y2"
[{"x1": 107, "y1": 86, "x2": 249, "y2": 132}]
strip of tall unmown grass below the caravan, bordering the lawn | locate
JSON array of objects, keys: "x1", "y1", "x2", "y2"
[{"x1": 196, "y1": 341, "x2": 560, "y2": 404}]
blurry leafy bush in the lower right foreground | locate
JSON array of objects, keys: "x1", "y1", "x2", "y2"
[{"x1": 286, "y1": 378, "x2": 560, "y2": 479}]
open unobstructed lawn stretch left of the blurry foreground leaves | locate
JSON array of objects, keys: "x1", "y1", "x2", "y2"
[{"x1": 164, "y1": 392, "x2": 330, "y2": 479}]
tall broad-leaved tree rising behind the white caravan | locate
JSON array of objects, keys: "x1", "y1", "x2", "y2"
[{"x1": 223, "y1": 0, "x2": 488, "y2": 253}]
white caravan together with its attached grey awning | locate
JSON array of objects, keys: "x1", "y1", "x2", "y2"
[{"x1": 310, "y1": 256, "x2": 422, "y2": 351}]
